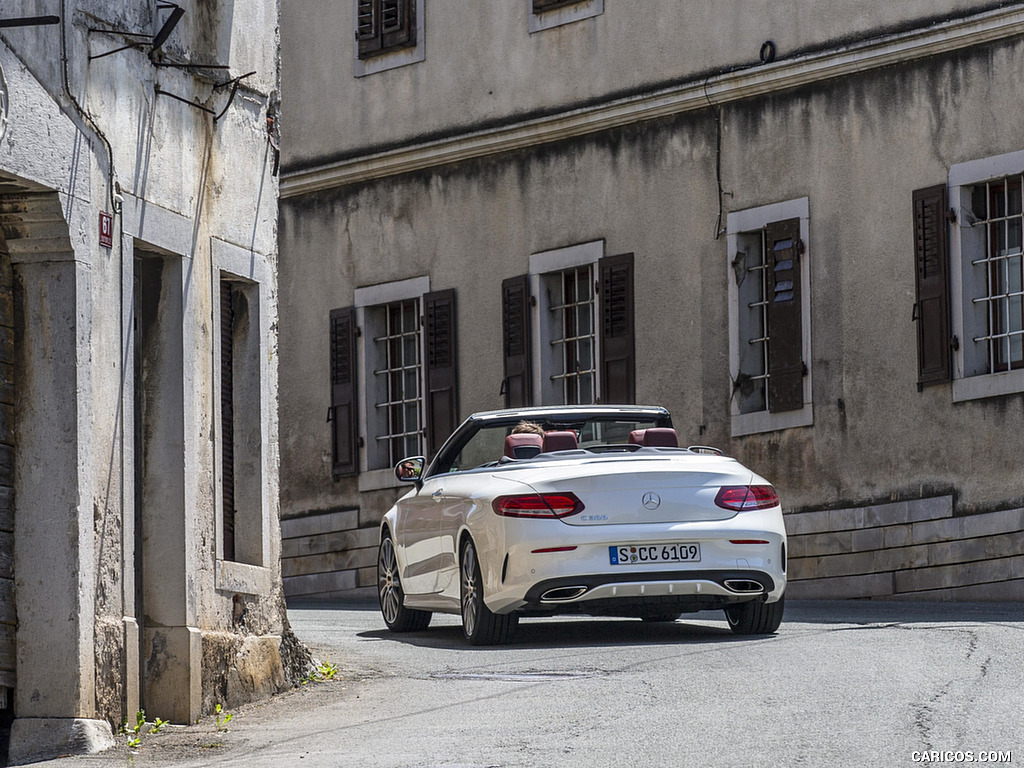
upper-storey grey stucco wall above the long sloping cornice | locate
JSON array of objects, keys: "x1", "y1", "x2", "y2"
[{"x1": 282, "y1": 0, "x2": 1002, "y2": 170}]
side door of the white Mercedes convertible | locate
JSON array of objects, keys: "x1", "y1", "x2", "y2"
[{"x1": 395, "y1": 475, "x2": 444, "y2": 595}]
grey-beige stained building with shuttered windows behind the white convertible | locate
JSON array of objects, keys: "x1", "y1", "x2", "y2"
[{"x1": 281, "y1": 0, "x2": 1024, "y2": 600}]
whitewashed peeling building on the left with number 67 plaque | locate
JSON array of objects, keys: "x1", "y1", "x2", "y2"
[{"x1": 0, "y1": 0, "x2": 289, "y2": 762}]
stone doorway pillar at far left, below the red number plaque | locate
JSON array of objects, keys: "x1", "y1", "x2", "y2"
[{"x1": 3, "y1": 194, "x2": 114, "y2": 764}]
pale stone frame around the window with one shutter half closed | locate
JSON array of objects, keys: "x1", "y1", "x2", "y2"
[{"x1": 726, "y1": 198, "x2": 814, "y2": 437}]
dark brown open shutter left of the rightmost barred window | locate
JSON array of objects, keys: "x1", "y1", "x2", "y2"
[{"x1": 913, "y1": 184, "x2": 952, "y2": 386}]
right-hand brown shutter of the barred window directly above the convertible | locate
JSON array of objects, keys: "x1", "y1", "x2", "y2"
[{"x1": 598, "y1": 253, "x2": 636, "y2": 403}]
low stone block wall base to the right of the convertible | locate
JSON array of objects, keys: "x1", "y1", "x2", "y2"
[{"x1": 785, "y1": 496, "x2": 1024, "y2": 600}]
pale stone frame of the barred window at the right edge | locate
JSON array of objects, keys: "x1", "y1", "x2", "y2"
[{"x1": 948, "y1": 150, "x2": 1024, "y2": 402}]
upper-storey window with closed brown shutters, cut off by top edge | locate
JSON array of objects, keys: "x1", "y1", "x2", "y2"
[{"x1": 355, "y1": 0, "x2": 424, "y2": 77}]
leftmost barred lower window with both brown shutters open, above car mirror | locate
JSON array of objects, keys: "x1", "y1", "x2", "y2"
[{"x1": 329, "y1": 278, "x2": 459, "y2": 481}]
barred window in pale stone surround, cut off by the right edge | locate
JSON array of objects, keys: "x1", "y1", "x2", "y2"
[{"x1": 942, "y1": 152, "x2": 1024, "y2": 400}]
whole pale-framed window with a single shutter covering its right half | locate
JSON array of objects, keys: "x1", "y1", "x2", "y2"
[{"x1": 727, "y1": 198, "x2": 813, "y2": 436}]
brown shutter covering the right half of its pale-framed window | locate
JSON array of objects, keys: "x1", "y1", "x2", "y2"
[{"x1": 765, "y1": 219, "x2": 805, "y2": 413}]
